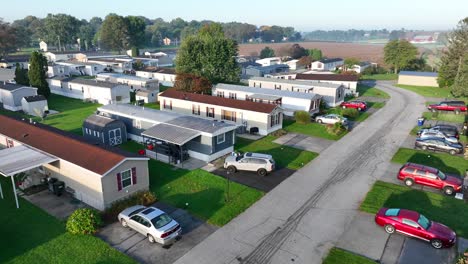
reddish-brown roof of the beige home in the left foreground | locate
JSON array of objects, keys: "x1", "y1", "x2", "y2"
[{"x1": 0, "y1": 115, "x2": 143, "y2": 175}]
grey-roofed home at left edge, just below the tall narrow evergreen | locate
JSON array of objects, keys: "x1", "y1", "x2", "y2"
[{"x1": 0, "y1": 82, "x2": 37, "y2": 111}]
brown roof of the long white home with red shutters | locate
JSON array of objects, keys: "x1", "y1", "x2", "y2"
[{"x1": 160, "y1": 88, "x2": 276, "y2": 114}]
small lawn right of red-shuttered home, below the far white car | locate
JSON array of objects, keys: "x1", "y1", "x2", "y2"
[{"x1": 283, "y1": 119, "x2": 348, "y2": 140}]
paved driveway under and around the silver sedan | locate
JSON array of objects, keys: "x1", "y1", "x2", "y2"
[{"x1": 98, "y1": 202, "x2": 217, "y2": 264}]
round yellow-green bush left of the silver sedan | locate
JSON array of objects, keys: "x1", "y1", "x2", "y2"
[{"x1": 66, "y1": 208, "x2": 102, "y2": 235}]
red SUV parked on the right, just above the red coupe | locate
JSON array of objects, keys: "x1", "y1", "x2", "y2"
[{"x1": 397, "y1": 162, "x2": 463, "y2": 195}]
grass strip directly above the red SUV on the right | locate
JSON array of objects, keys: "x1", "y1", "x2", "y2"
[{"x1": 392, "y1": 148, "x2": 468, "y2": 175}]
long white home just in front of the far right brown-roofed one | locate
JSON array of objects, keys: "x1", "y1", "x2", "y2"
[{"x1": 249, "y1": 77, "x2": 345, "y2": 107}]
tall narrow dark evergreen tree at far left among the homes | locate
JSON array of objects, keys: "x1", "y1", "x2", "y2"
[{"x1": 28, "y1": 51, "x2": 50, "y2": 97}]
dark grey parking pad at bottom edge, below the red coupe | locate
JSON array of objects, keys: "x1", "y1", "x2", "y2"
[{"x1": 398, "y1": 238, "x2": 457, "y2": 264}]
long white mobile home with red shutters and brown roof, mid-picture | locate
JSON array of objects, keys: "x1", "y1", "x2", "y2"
[{"x1": 159, "y1": 89, "x2": 283, "y2": 135}]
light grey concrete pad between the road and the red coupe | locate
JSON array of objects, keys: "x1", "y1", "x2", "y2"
[{"x1": 337, "y1": 212, "x2": 389, "y2": 260}]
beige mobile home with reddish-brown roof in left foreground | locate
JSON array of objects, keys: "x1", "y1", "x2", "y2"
[{"x1": 0, "y1": 115, "x2": 149, "y2": 210}]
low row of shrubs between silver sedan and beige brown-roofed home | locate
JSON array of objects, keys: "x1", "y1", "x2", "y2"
[{"x1": 103, "y1": 191, "x2": 156, "y2": 224}]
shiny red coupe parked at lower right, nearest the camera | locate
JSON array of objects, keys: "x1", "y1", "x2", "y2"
[{"x1": 375, "y1": 208, "x2": 457, "y2": 249}]
